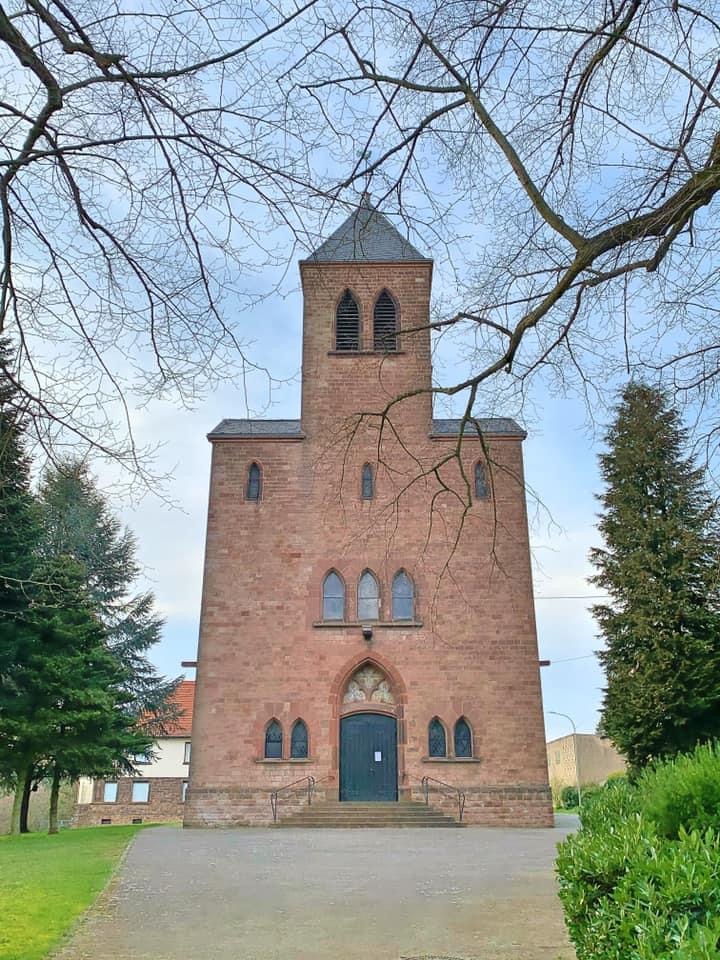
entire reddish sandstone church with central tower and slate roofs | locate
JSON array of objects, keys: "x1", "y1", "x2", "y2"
[{"x1": 184, "y1": 199, "x2": 552, "y2": 827}]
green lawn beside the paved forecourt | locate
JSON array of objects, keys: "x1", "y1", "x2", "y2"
[{"x1": 0, "y1": 826, "x2": 143, "y2": 960}]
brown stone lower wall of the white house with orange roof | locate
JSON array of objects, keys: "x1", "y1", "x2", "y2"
[{"x1": 73, "y1": 777, "x2": 185, "y2": 827}]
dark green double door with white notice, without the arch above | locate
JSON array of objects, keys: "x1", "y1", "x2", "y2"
[{"x1": 340, "y1": 713, "x2": 397, "y2": 800}]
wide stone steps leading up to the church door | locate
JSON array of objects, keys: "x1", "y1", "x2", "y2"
[{"x1": 273, "y1": 800, "x2": 463, "y2": 829}]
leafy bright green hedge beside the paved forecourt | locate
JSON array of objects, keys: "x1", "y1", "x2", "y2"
[{"x1": 557, "y1": 746, "x2": 720, "y2": 960}]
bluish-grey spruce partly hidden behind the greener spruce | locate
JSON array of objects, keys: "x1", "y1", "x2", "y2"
[{"x1": 39, "y1": 458, "x2": 178, "y2": 732}]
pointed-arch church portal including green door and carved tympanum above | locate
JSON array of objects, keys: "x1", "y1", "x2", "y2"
[{"x1": 340, "y1": 663, "x2": 398, "y2": 801}]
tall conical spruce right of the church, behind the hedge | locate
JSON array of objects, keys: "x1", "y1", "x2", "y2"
[{"x1": 591, "y1": 384, "x2": 720, "y2": 769}]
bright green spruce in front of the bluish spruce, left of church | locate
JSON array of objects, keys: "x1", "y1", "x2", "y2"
[{"x1": 3, "y1": 557, "x2": 152, "y2": 833}]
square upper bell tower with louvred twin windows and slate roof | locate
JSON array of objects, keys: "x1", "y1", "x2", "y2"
[{"x1": 300, "y1": 204, "x2": 432, "y2": 437}]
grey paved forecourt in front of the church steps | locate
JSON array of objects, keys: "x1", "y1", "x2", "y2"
[{"x1": 60, "y1": 827, "x2": 574, "y2": 960}]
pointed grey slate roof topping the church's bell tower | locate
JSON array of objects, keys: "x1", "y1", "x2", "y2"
[{"x1": 305, "y1": 199, "x2": 430, "y2": 263}]
